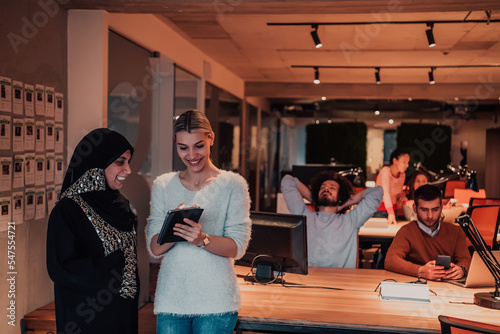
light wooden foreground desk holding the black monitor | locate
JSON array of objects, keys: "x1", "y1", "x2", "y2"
[{"x1": 236, "y1": 266, "x2": 500, "y2": 333}]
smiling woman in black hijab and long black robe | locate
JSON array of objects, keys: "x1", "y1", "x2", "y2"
[{"x1": 47, "y1": 129, "x2": 139, "y2": 334}]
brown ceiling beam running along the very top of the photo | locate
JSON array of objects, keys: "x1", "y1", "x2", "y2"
[{"x1": 65, "y1": 0, "x2": 500, "y2": 15}]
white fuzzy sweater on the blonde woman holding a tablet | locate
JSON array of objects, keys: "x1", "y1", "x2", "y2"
[{"x1": 146, "y1": 171, "x2": 251, "y2": 315}]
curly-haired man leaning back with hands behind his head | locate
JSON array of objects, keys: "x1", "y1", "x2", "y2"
[{"x1": 281, "y1": 170, "x2": 383, "y2": 268}]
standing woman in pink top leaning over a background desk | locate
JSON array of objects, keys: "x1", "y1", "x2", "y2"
[{"x1": 375, "y1": 149, "x2": 410, "y2": 224}]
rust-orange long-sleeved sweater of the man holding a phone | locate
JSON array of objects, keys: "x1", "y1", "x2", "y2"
[{"x1": 385, "y1": 221, "x2": 471, "y2": 276}]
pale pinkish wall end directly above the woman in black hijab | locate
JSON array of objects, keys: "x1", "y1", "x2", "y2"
[{"x1": 67, "y1": 10, "x2": 108, "y2": 154}]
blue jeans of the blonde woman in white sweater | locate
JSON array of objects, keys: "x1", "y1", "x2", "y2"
[{"x1": 156, "y1": 312, "x2": 238, "y2": 334}]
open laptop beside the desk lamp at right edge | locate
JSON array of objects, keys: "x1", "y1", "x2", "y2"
[{"x1": 446, "y1": 251, "x2": 500, "y2": 288}]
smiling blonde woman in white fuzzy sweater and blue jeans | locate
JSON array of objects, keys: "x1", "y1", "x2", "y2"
[{"x1": 147, "y1": 110, "x2": 251, "y2": 334}]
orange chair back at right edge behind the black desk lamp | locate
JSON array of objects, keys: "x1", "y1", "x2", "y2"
[{"x1": 467, "y1": 205, "x2": 500, "y2": 250}]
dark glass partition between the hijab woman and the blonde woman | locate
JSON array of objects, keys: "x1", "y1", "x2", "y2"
[{"x1": 107, "y1": 31, "x2": 155, "y2": 301}]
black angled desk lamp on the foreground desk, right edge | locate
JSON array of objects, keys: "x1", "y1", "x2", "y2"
[{"x1": 455, "y1": 215, "x2": 500, "y2": 310}]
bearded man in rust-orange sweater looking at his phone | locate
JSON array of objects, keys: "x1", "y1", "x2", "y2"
[{"x1": 385, "y1": 184, "x2": 471, "y2": 280}]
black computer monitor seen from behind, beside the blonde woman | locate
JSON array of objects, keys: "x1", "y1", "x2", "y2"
[{"x1": 236, "y1": 212, "x2": 308, "y2": 283}]
